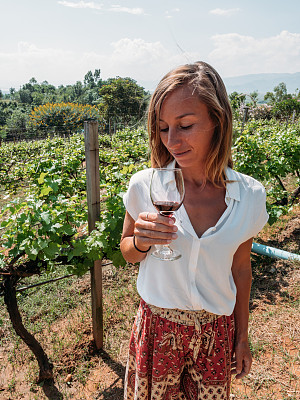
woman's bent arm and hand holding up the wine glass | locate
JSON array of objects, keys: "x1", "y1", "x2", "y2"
[{"x1": 120, "y1": 211, "x2": 178, "y2": 263}]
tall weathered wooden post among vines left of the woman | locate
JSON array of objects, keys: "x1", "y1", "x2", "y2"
[{"x1": 84, "y1": 121, "x2": 103, "y2": 349}]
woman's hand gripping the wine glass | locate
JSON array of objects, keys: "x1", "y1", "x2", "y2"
[{"x1": 133, "y1": 212, "x2": 178, "y2": 250}]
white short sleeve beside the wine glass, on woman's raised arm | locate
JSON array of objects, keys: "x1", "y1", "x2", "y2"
[{"x1": 123, "y1": 169, "x2": 153, "y2": 221}]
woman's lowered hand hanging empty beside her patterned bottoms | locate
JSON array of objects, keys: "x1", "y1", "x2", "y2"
[{"x1": 231, "y1": 340, "x2": 252, "y2": 379}]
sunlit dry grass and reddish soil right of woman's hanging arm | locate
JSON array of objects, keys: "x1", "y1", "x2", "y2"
[{"x1": 233, "y1": 263, "x2": 300, "y2": 400}]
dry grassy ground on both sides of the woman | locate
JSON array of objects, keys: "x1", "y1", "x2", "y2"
[{"x1": 0, "y1": 208, "x2": 300, "y2": 400}]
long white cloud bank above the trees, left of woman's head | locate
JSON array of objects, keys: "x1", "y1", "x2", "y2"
[{"x1": 0, "y1": 38, "x2": 197, "y2": 90}]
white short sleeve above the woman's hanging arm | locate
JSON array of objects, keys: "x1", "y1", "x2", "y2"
[{"x1": 250, "y1": 185, "x2": 269, "y2": 237}]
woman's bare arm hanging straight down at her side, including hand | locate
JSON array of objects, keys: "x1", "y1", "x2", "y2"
[{"x1": 232, "y1": 238, "x2": 253, "y2": 379}]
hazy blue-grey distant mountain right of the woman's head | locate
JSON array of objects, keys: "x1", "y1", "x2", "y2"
[{"x1": 224, "y1": 72, "x2": 300, "y2": 94}]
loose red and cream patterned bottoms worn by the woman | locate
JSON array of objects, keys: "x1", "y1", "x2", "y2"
[{"x1": 124, "y1": 300, "x2": 234, "y2": 400}]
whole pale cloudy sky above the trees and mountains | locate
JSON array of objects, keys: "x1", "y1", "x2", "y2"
[{"x1": 0, "y1": 0, "x2": 300, "y2": 91}]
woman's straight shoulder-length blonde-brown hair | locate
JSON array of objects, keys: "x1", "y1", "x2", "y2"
[{"x1": 148, "y1": 61, "x2": 232, "y2": 186}]
